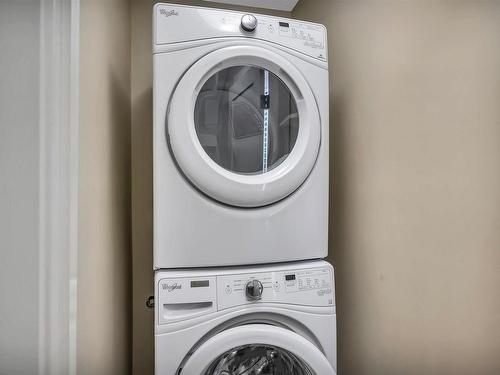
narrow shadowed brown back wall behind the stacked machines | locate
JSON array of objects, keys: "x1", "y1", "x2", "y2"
[{"x1": 131, "y1": 0, "x2": 290, "y2": 375}]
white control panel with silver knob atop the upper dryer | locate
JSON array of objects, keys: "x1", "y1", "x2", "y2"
[{"x1": 154, "y1": 4, "x2": 328, "y2": 62}]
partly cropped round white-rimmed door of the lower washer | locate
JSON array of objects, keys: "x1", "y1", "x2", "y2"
[{"x1": 178, "y1": 324, "x2": 336, "y2": 375}]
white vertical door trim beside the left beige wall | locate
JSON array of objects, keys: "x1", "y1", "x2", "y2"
[{"x1": 38, "y1": 0, "x2": 80, "y2": 375}]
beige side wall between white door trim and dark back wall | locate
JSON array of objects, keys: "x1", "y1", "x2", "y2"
[{"x1": 77, "y1": 0, "x2": 132, "y2": 375}]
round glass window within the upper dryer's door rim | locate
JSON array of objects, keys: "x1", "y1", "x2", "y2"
[{"x1": 194, "y1": 66, "x2": 299, "y2": 175}]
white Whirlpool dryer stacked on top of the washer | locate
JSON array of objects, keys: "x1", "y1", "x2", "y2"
[{"x1": 153, "y1": 4, "x2": 328, "y2": 269}]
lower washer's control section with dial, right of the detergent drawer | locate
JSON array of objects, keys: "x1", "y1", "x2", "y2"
[{"x1": 217, "y1": 267, "x2": 334, "y2": 310}]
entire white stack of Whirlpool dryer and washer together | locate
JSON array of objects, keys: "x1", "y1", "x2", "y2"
[{"x1": 153, "y1": 4, "x2": 336, "y2": 375}]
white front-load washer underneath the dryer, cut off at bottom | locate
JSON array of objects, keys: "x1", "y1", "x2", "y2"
[{"x1": 155, "y1": 261, "x2": 337, "y2": 375}]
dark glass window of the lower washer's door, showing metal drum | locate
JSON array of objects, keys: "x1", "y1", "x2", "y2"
[{"x1": 203, "y1": 344, "x2": 315, "y2": 375}]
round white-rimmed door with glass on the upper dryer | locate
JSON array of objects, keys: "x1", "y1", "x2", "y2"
[{"x1": 167, "y1": 46, "x2": 321, "y2": 207}]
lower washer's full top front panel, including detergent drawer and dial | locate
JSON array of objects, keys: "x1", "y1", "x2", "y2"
[{"x1": 156, "y1": 261, "x2": 335, "y2": 324}]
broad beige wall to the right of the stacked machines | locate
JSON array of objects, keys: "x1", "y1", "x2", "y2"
[{"x1": 293, "y1": 0, "x2": 500, "y2": 375}]
